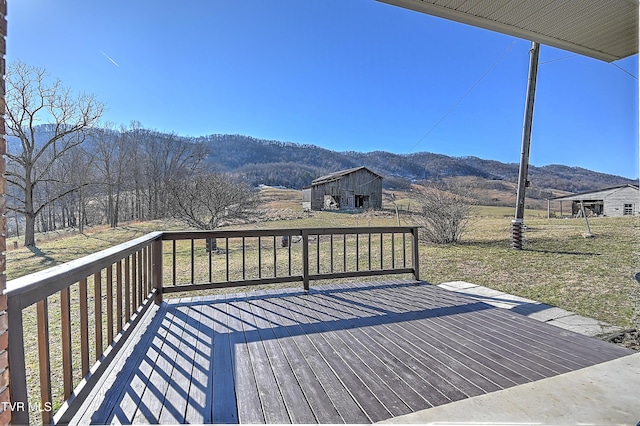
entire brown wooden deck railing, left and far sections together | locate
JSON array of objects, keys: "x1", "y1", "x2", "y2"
[{"x1": 5, "y1": 227, "x2": 419, "y2": 424}]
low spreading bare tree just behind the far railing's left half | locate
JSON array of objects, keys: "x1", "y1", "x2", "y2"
[{"x1": 167, "y1": 173, "x2": 260, "y2": 230}]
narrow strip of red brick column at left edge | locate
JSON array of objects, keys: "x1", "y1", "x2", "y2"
[{"x1": 0, "y1": 0, "x2": 11, "y2": 425}]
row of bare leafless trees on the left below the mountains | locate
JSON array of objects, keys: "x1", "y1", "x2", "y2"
[{"x1": 5, "y1": 62, "x2": 257, "y2": 247}]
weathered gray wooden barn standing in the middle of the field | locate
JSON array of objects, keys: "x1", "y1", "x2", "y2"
[{"x1": 302, "y1": 167, "x2": 382, "y2": 210}]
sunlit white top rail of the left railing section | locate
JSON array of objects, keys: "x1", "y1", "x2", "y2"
[{"x1": 3, "y1": 232, "x2": 162, "y2": 307}]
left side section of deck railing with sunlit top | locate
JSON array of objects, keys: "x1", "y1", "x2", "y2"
[{"x1": 5, "y1": 232, "x2": 162, "y2": 424}]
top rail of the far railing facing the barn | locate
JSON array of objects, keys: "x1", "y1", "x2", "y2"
[{"x1": 162, "y1": 226, "x2": 416, "y2": 240}]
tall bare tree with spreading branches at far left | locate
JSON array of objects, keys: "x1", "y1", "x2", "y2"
[{"x1": 6, "y1": 62, "x2": 104, "y2": 247}]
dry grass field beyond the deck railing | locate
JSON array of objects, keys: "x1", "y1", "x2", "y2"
[{"x1": 7, "y1": 201, "x2": 640, "y2": 327}]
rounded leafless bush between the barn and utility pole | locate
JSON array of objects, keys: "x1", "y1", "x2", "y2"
[{"x1": 416, "y1": 182, "x2": 475, "y2": 244}]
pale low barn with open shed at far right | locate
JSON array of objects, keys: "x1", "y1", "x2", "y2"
[{"x1": 548, "y1": 185, "x2": 640, "y2": 217}]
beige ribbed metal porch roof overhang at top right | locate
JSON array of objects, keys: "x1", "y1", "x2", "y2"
[{"x1": 378, "y1": 0, "x2": 638, "y2": 62}]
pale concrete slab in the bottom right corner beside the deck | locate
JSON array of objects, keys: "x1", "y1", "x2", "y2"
[{"x1": 382, "y1": 354, "x2": 640, "y2": 425}]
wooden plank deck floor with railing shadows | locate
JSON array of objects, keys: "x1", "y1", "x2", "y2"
[{"x1": 74, "y1": 281, "x2": 632, "y2": 424}]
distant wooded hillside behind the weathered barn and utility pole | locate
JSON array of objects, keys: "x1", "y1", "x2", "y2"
[{"x1": 196, "y1": 135, "x2": 637, "y2": 197}]
